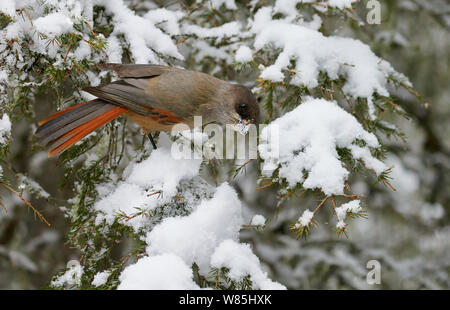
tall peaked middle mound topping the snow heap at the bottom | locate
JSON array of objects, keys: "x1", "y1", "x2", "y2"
[{"x1": 146, "y1": 183, "x2": 243, "y2": 270}]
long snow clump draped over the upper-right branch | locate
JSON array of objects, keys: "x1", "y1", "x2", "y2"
[{"x1": 251, "y1": 6, "x2": 409, "y2": 107}]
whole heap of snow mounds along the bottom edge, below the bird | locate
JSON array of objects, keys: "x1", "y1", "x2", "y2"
[{"x1": 119, "y1": 183, "x2": 284, "y2": 289}]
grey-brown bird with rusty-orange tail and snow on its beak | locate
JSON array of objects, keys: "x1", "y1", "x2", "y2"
[{"x1": 35, "y1": 63, "x2": 259, "y2": 157}]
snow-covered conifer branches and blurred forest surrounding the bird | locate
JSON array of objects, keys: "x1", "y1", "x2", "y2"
[{"x1": 0, "y1": 0, "x2": 450, "y2": 289}]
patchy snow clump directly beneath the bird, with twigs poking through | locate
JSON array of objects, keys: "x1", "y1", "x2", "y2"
[{"x1": 94, "y1": 135, "x2": 201, "y2": 230}]
